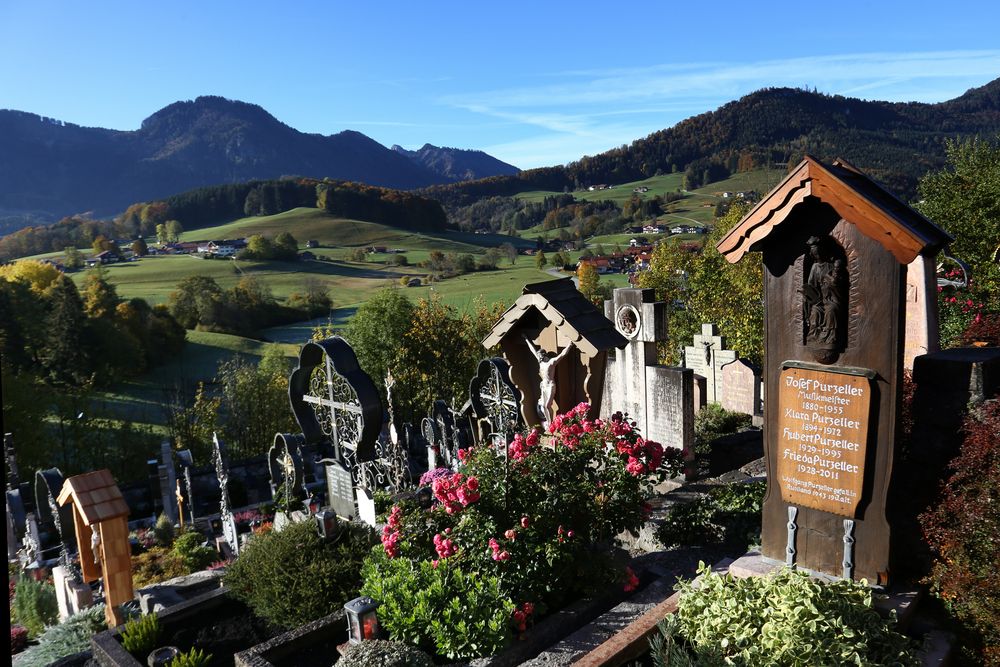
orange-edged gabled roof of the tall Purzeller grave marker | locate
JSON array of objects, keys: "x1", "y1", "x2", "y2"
[{"x1": 716, "y1": 155, "x2": 954, "y2": 264}]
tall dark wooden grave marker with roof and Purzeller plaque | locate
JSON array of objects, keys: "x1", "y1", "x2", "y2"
[{"x1": 717, "y1": 157, "x2": 950, "y2": 584}]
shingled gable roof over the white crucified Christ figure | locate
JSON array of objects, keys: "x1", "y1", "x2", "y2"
[{"x1": 483, "y1": 278, "x2": 628, "y2": 357}]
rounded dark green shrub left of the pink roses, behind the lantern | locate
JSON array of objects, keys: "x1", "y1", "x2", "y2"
[{"x1": 224, "y1": 521, "x2": 376, "y2": 628}]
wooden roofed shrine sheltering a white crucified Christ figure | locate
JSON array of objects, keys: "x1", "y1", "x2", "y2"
[{"x1": 483, "y1": 278, "x2": 628, "y2": 426}]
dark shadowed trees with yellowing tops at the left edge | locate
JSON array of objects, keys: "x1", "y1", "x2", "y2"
[{"x1": 0, "y1": 260, "x2": 185, "y2": 486}]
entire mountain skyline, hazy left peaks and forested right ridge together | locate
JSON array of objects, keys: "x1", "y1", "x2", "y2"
[{"x1": 0, "y1": 79, "x2": 1000, "y2": 233}]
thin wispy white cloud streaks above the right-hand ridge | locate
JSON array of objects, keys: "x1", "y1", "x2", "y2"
[{"x1": 446, "y1": 49, "x2": 1000, "y2": 167}]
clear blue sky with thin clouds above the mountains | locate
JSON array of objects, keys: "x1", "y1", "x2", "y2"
[{"x1": 0, "y1": 0, "x2": 1000, "y2": 168}]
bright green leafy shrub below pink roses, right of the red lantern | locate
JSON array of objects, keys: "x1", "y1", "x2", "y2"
[{"x1": 361, "y1": 547, "x2": 514, "y2": 660}]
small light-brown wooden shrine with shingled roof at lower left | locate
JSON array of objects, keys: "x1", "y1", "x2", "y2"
[{"x1": 58, "y1": 470, "x2": 134, "y2": 627}]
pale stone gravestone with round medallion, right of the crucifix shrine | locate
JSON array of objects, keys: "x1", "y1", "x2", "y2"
[{"x1": 601, "y1": 288, "x2": 694, "y2": 452}]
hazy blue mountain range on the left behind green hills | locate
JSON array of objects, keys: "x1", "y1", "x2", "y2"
[{"x1": 0, "y1": 97, "x2": 518, "y2": 224}]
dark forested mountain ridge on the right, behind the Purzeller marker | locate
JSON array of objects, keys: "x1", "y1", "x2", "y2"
[{"x1": 424, "y1": 79, "x2": 1000, "y2": 207}]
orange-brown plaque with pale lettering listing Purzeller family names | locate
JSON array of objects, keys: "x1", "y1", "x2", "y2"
[{"x1": 777, "y1": 362, "x2": 872, "y2": 518}]
